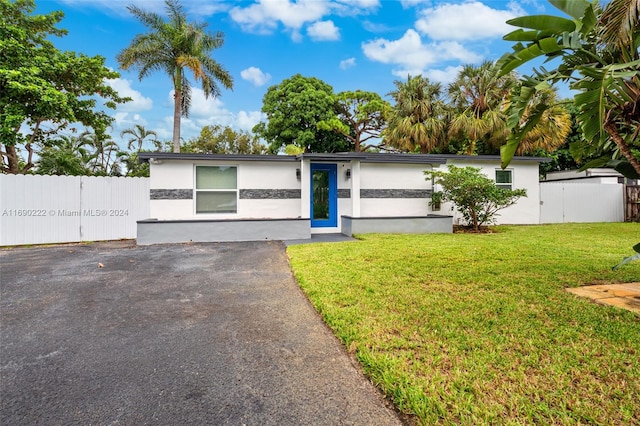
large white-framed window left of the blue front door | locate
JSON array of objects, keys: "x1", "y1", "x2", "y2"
[{"x1": 195, "y1": 166, "x2": 238, "y2": 214}]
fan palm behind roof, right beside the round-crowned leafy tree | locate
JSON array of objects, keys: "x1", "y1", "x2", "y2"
[{"x1": 383, "y1": 75, "x2": 446, "y2": 154}]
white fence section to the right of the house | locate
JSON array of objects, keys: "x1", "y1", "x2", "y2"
[{"x1": 540, "y1": 182, "x2": 624, "y2": 223}]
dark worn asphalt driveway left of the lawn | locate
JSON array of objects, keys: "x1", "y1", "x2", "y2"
[{"x1": 0, "y1": 242, "x2": 400, "y2": 425}]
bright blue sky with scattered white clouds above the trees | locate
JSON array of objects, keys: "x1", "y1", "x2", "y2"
[{"x1": 36, "y1": 0, "x2": 556, "y2": 146}]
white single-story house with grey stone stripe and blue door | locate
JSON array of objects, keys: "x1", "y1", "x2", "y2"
[{"x1": 137, "y1": 152, "x2": 544, "y2": 244}]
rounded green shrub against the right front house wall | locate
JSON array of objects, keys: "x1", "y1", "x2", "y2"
[{"x1": 424, "y1": 165, "x2": 527, "y2": 231}]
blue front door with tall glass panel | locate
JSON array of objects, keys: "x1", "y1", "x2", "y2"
[{"x1": 311, "y1": 164, "x2": 338, "y2": 228}]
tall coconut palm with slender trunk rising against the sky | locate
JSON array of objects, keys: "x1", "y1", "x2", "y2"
[{"x1": 117, "y1": 0, "x2": 233, "y2": 152}]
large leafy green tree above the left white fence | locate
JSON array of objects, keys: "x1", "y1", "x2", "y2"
[{"x1": 0, "y1": 0, "x2": 129, "y2": 174}]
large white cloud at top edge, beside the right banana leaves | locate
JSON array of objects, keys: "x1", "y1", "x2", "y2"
[{"x1": 415, "y1": 1, "x2": 525, "y2": 40}]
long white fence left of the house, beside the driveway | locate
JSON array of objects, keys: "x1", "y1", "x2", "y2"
[{"x1": 0, "y1": 175, "x2": 149, "y2": 246}]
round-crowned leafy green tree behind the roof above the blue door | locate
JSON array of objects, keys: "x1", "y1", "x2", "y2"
[{"x1": 318, "y1": 90, "x2": 391, "y2": 152}]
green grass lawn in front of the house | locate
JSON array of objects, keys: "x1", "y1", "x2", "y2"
[{"x1": 288, "y1": 223, "x2": 640, "y2": 424}]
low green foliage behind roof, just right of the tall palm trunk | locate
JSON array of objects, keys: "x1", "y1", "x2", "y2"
[{"x1": 184, "y1": 124, "x2": 267, "y2": 154}]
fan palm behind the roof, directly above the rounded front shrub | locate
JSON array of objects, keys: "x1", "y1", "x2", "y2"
[{"x1": 448, "y1": 61, "x2": 516, "y2": 155}]
